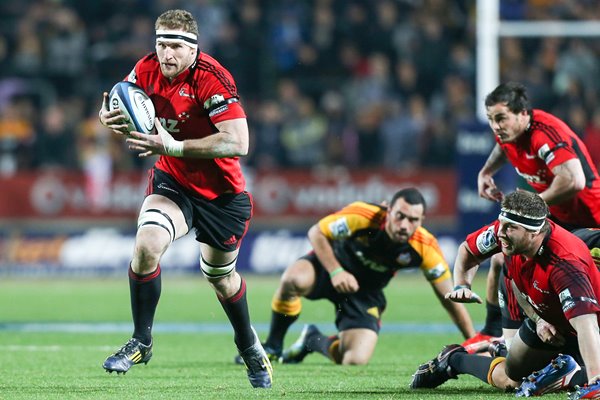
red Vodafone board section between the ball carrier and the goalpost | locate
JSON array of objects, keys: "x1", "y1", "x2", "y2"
[{"x1": 249, "y1": 169, "x2": 456, "y2": 218}]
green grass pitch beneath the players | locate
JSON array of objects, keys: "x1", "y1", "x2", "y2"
[{"x1": 0, "y1": 271, "x2": 566, "y2": 400}]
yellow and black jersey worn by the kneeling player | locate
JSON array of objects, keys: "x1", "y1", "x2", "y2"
[{"x1": 318, "y1": 201, "x2": 450, "y2": 289}]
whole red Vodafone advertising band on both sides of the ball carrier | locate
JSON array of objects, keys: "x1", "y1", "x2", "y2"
[{"x1": 0, "y1": 169, "x2": 456, "y2": 219}]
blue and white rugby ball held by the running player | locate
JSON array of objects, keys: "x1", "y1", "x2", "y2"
[{"x1": 108, "y1": 81, "x2": 156, "y2": 134}]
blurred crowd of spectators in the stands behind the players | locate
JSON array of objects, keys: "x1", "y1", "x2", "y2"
[{"x1": 0, "y1": 0, "x2": 600, "y2": 175}]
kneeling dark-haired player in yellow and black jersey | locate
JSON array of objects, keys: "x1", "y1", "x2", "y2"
[{"x1": 237, "y1": 188, "x2": 475, "y2": 365}]
